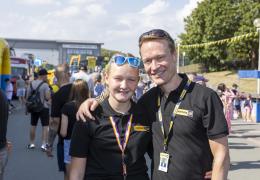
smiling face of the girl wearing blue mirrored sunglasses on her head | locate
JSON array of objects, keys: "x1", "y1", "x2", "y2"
[{"x1": 105, "y1": 63, "x2": 139, "y2": 103}]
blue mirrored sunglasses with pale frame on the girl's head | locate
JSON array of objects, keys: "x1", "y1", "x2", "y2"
[{"x1": 111, "y1": 55, "x2": 140, "y2": 68}]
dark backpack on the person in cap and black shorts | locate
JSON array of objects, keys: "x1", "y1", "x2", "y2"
[{"x1": 26, "y1": 82, "x2": 44, "y2": 113}]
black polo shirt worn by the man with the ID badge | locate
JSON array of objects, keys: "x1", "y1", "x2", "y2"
[{"x1": 139, "y1": 74, "x2": 228, "y2": 180}]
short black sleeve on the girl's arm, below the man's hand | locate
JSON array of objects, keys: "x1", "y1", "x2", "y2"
[{"x1": 70, "y1": 121, "x2": 91, "y2": 158}]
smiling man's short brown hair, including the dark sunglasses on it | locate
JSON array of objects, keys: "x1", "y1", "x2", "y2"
[{"x1": 138, "y1": 29, "x2": 175, "y2": 52}]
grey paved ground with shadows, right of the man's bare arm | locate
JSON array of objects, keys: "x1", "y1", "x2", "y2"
[{"x1": 228, "y1": 120, "x2": 260, "y2": 180}]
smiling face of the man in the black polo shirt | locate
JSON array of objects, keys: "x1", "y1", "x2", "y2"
[{"x1": 140, "y1": 39, "x2": 176, "y2": 86}]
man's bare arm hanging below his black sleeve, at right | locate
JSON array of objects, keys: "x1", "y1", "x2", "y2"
[{"x1": 209, "y1": 136, "x2": 230, "y2": 180}]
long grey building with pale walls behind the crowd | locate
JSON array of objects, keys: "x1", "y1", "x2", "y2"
[{"x1": 5, "y1": 38, "x2": 103, "y2": 65}]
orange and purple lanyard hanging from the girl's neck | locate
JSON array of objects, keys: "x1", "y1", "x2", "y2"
[{"x1": 109, "y1": 114, "x2": 133, "y2": 179}]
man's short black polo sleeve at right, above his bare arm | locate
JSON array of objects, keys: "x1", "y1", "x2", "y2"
[{"x1": 203, "y1": 91, "x2": 228, "y2": 139}]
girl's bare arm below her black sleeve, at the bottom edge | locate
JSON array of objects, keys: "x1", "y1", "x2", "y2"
[{"x1": 69, "y1": 156, "x2": 87, "y2": 180}]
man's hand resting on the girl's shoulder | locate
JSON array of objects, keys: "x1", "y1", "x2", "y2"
[{"x1": 77, "y1": 98, "x2": 98, "y2": 122}]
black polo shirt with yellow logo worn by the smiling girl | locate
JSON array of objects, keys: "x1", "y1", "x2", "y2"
[{"x1": 70, "y1": 98, "x2": 151, "y2": 180}]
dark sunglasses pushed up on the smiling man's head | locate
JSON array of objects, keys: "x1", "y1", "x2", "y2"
[{"x1": 139, "y1": 29, "x2": 174, "y2": 45}]
